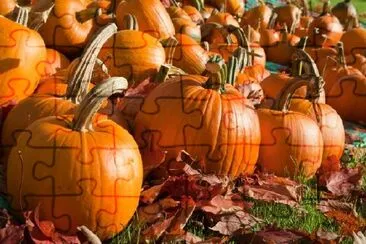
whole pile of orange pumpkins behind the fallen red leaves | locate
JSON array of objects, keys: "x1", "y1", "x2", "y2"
[{"x1": 0, "y1": 0, "x2": 366, "y2": 240}]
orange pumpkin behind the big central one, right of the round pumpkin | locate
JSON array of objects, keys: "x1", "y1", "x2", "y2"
[{"x1": 173, "y1": 34, "x2": 209, "y2": 75}]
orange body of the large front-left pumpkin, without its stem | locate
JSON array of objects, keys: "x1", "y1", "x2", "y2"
[{"x1": 7, "y1": 117, "x2": 142, "y2": 240}]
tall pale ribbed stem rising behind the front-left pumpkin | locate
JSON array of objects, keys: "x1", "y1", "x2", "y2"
[{"x1": 66, "y1": 23, "x2": 117, "y2": 104}]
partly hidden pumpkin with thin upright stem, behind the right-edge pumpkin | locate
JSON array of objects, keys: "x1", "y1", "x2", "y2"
[{"x1": 323, "y1": 42, "x2": 362, "y2": 94}]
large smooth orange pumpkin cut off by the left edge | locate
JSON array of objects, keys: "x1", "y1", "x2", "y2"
[{"x1": 0, "y1": 16, "x2": 46, "y2": 106}]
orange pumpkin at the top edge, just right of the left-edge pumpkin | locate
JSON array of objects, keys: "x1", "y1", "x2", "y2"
[{"x1": 39, "y1": 0, "x2": 96, "y2": 56}]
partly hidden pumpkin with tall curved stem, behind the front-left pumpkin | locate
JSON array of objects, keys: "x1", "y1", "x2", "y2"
[{"x1": 1, "y1": 24, "x2": 117, "y2": 152}]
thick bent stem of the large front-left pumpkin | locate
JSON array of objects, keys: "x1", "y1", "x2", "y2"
[{"x1": 71, "y1": 77, "x2": 128, "y2": 132}]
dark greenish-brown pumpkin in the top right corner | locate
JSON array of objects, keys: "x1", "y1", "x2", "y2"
[{"x1": 332, "y1": 0, "x2": 359, "y2": 30}]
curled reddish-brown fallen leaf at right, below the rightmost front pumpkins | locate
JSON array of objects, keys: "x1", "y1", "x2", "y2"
[{"x1": 326, "y1": 167, "x2": 362, "y2": 196}]
